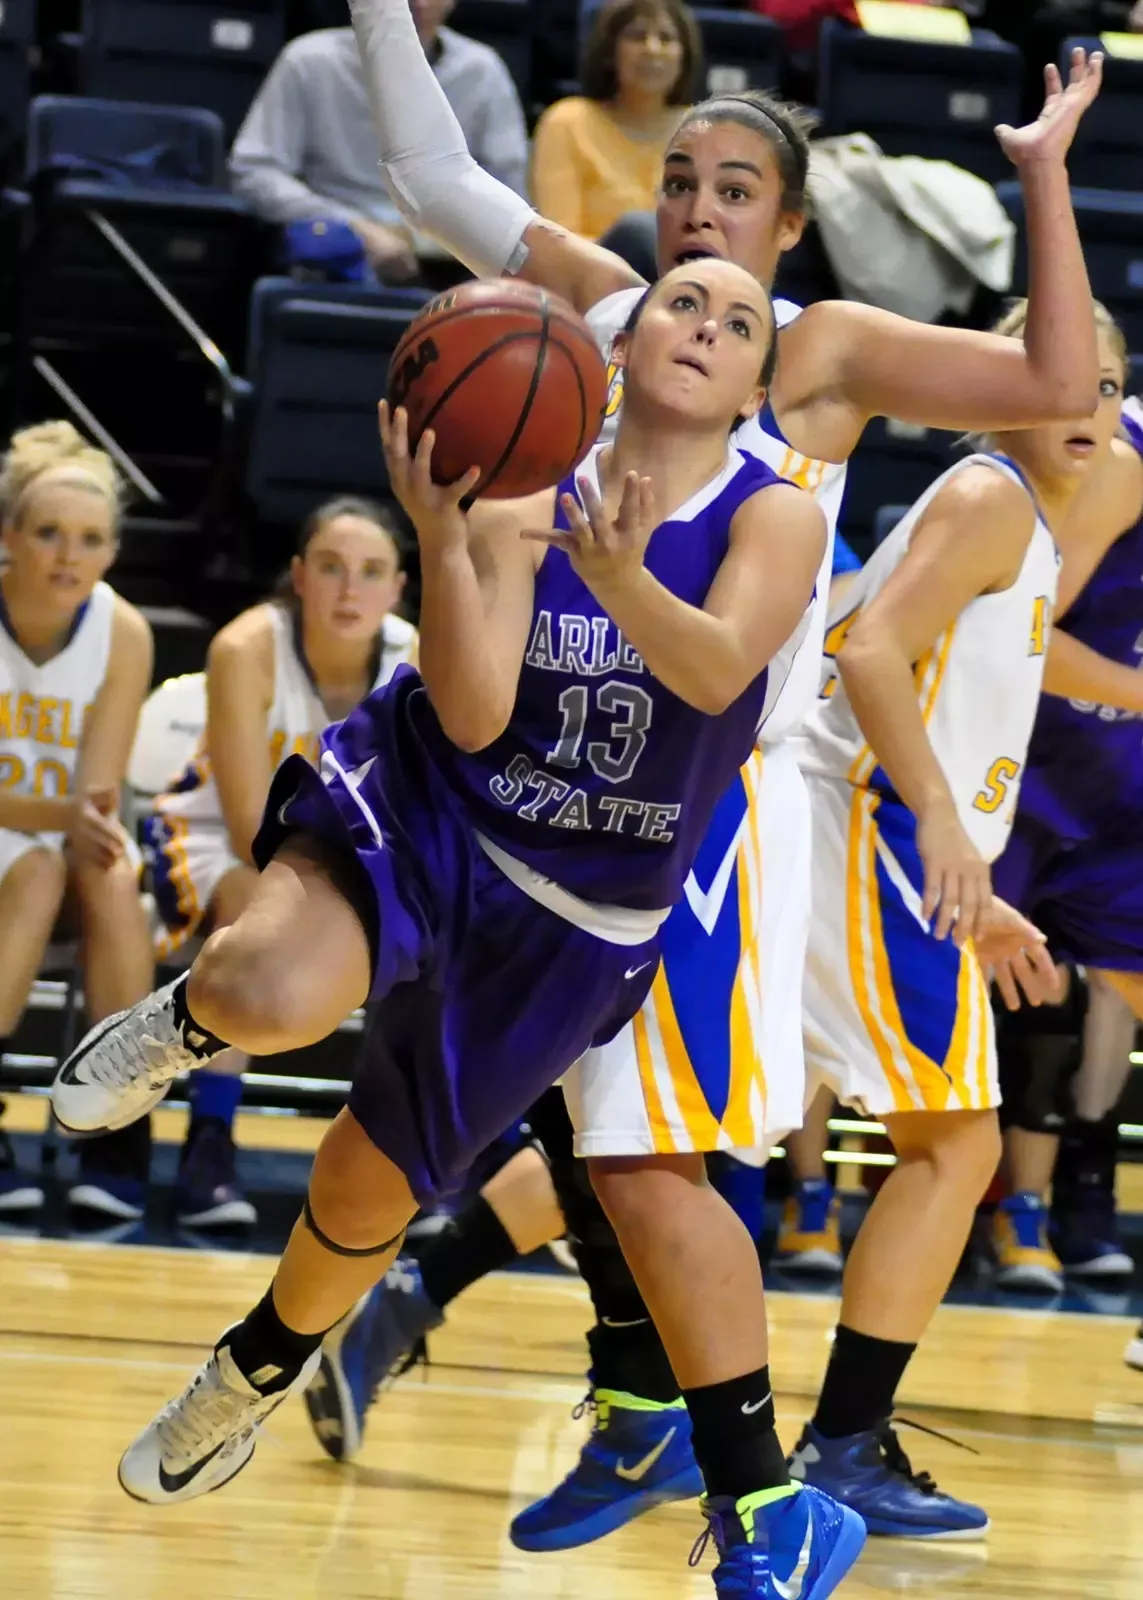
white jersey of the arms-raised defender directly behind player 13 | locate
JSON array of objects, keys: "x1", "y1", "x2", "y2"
[{"x1": 586, "y1": 290, "x2": 845, "y2": 746}]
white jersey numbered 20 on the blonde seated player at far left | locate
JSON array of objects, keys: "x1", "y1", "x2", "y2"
[{"x1": 0, "y1": 584, "x2": 115, "y2": 797}]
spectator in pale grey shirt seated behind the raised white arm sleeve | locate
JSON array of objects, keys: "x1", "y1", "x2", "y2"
[{"x1": 231, "y1": 0, "x2": 528, "y2": 283}]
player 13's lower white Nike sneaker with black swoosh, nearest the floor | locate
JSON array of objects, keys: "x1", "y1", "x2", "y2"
[{"x1": 118, "y1": 1328, "x2": 322, "y2": 1506}]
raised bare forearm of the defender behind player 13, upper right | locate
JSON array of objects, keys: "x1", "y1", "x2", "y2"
[{"x1": 1020, "y1": 162, "x2": 1100, "y2": 418}]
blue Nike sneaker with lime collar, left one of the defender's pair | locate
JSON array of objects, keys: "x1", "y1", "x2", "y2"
[{"x1": 509, "y1": 1389, "x2": 703, "y2": 1550}]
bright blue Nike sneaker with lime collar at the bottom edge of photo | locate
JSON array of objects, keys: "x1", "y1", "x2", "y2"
[{"x1": 690, "y1": 1485, "x2": 864, "y2": 1600}]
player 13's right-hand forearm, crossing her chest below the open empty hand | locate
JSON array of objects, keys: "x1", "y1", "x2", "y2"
[{"x1": 589, "y1": 566, "x2": 759, "y2": 717}]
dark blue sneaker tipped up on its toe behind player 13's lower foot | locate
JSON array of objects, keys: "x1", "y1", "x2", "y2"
[{"x1": 303, "y1": 1259, "x2": 445, "y2": 1461}]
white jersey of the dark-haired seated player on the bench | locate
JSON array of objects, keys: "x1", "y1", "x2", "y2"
[{"x1": 155, "y1": 603, "x2": 416, "y2": 826}]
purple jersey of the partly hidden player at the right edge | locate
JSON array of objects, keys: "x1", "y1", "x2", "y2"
[{"x1": 1020, "y1": 414, "x2": 1143, "y2": 840}]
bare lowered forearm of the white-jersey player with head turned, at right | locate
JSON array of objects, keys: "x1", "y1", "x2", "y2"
[{"x1": 837, "y1": 642, "x2": 954, "y2": 818}]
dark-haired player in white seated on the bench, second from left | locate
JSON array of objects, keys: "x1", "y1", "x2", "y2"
[{"x1": 144, "y1": 492, "x2": 416, "y2": 1227}]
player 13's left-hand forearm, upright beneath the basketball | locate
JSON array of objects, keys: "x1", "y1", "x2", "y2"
[{"x1": 419, "y1": 547, "x2": 515, "y2": 750}]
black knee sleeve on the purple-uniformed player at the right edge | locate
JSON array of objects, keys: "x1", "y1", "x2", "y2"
[{"x1": 996, "y1": 973, "x2": 1087, "y2": 1133}]
